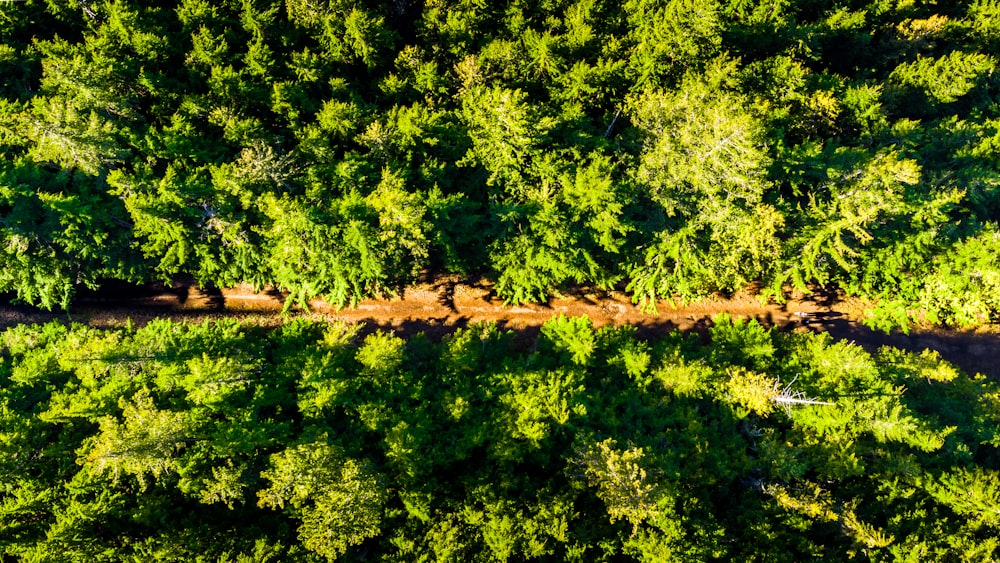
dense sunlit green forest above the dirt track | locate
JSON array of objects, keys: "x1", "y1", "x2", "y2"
[{"x1": 0, "y1": 0, "x2": 1000, "y2": 329}]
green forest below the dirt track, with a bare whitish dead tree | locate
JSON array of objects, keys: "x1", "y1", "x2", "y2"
[{"x1": 0, "y1": 316, "x2": 1000, "y2": 563}]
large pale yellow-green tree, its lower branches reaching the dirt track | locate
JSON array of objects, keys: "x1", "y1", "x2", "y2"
[{"x1": 629, "y1": 61, "x2": 784, "y2": 306}]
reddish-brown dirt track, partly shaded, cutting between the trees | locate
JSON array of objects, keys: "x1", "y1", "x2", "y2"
[{"x1": 0, "y1": 277, "x2": 1000, "y2": 380}]
